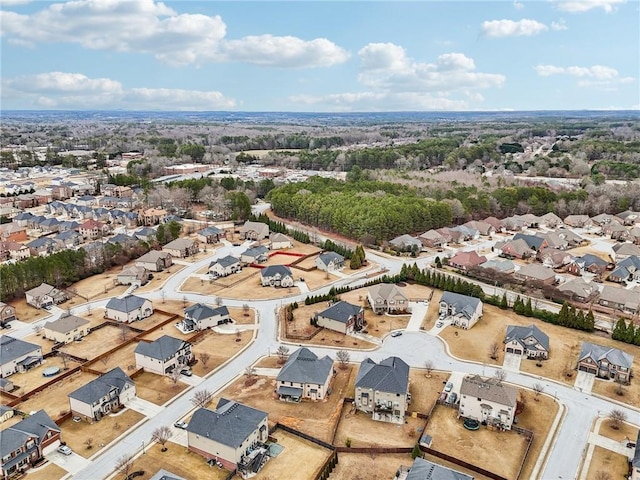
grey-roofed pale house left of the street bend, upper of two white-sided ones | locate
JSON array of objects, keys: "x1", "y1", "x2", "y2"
[{"x1": 133, "y1": 335, "x2": 193, "y2": 375}]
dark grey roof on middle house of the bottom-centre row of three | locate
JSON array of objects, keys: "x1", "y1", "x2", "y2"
[{"x1": 356, "y1": 357, "x2": 409, "y2": 394}]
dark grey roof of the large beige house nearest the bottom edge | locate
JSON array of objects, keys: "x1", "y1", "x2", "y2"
[{"x1": 186, "y1": 398, "x2": 267, "y2": 449}]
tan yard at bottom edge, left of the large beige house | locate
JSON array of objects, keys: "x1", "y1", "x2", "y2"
[{"x1": 123, "y1": 441, "x2": 229, "y2": 480}]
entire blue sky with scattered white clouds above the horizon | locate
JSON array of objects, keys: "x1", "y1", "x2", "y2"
[{"x1": 0, "y1": 0, "x2": 640, "y2": 112}]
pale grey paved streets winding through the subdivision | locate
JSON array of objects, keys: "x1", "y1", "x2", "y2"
[{"x1": 6, "y1": 208, "x2": 640, "y2": 480}]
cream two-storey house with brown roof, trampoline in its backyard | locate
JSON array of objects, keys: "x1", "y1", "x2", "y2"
[{"x1": 458, "y1": 375, "x2": 518, "y2": 430}]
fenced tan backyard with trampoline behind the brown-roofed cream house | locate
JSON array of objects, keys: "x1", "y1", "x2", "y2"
[{"x1": 427, "y1": 405, "x2": 535, "y2": 478}]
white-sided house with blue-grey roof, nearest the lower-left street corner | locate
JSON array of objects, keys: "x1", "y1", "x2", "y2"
[{"x1": 67, "y1": 367, "x2": 136, "y2": 422}]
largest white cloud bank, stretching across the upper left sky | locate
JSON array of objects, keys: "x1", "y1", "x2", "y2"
[{"x1": 0, "y1": 0, "x2": 348, "y2": 67}]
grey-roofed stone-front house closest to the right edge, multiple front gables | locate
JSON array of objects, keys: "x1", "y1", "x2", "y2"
[{"x1": 577, "y1": 342, "x2": 633, "y2": 383}]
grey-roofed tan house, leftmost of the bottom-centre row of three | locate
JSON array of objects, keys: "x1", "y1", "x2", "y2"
[{"x1": 276, "y1": 347, "x2": 335, "y2": 402}]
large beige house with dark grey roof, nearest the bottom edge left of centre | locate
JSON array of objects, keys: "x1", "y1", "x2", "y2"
[{"x1": 186, "y1": 398, "x2": 269, "y2": 471}]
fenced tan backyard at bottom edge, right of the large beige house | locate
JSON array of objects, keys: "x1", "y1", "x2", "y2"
[{"x1": 254, "y1": 430, "x2": 331, "y2": 480}]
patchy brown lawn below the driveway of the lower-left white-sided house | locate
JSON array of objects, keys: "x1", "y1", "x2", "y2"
[{"x1": 61, "y1": 409, "x2": 144, "y2": 458}]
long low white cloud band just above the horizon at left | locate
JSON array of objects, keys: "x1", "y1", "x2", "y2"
[{"x1": 2, "y1": 72, "x2": 236, "y2": 110}]
